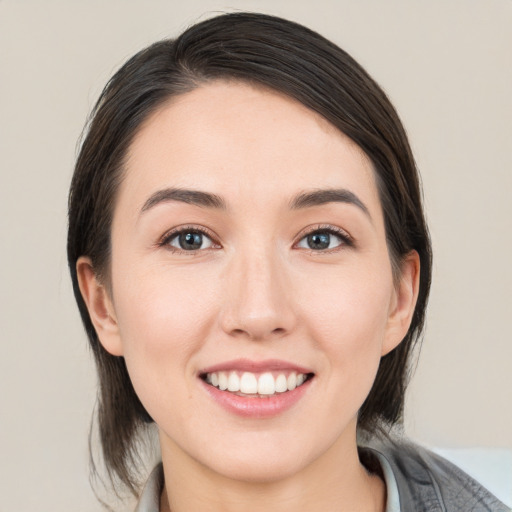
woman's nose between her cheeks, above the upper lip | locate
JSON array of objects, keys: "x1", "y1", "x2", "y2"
[{"x1": 220, "y1": 250, "x2": 296, "y2": 340}]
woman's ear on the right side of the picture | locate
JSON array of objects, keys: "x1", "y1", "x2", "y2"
[{"x1": 381, "y1": 251, "x2": 420, "y2": 356}]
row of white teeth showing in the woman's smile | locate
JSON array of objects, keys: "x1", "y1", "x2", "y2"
[{"x1": 205, "y1": 371, "x2": 307, "y2": 396}]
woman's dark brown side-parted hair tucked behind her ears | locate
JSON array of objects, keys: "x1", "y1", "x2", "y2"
[{"x1": 68, "y1": 13, "x2": 432, "y2": 493}]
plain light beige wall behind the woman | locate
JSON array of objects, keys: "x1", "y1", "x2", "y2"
[{"x1": 0, "y1": 0, "x2": 512, "y2": 512}]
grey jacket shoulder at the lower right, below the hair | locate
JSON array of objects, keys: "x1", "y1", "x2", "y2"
[{"x1": 367, "y1": 441, "x2": 510, "y2": 512}]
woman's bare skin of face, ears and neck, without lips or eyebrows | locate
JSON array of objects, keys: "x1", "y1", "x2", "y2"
[{"x1": 77, "y1": 81, "x2": 419, "y2": 512}]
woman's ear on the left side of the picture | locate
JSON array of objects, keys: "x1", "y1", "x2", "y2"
[{"x1": 76, "y1": 256, "x2": 123, "y2": 356}]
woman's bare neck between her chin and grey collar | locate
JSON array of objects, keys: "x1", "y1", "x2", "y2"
[{"x1": 160, "y1": 426, "x2": 386, "y2": 512}]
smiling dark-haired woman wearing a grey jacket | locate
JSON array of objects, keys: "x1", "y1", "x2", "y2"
[{"x1": 68, "y1": 13, "x2": 506, "y2": 512}]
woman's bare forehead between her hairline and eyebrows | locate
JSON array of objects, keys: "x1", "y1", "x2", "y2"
[{"x1": 119, "y1": 81, "x2": 378, "y2": 214}]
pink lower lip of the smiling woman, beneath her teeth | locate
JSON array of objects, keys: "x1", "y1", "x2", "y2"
[{"x1": 201, "y1": 379, "x2": 312, "y2": 418}]
